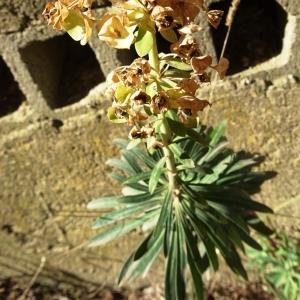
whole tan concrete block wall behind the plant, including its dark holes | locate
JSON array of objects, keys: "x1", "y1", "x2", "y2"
[{"x1": 0, "y1": 0, "x2": 300, "y2": 290}]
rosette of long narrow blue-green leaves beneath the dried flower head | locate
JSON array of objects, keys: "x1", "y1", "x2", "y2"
[{"x1": 88, "y1": 124, "x2": 271, "y2": 299}]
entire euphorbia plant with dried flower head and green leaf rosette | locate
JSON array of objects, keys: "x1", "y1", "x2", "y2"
[{"x1": 44, "y1": 0, "x2": 271, "y2": 300}]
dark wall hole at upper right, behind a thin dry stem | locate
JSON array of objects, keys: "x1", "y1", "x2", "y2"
[{"x1": 210, "y1": 0, "x2": 287, "y2": 75}]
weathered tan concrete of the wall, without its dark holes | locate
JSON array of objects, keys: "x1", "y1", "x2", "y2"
[{"x1": 0, "y1": 0, "x2": 300, "y2": 290}]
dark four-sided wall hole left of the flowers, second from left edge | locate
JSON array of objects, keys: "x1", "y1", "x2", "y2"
[{"x1": 20, "y1": 35, "x2": 105, "y2": 109}]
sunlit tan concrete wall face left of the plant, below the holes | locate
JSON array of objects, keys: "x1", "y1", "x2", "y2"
[{"x1": 0, "y1": 97, "x2": 145, "y2": 283}]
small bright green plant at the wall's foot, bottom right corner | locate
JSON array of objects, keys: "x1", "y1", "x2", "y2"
[{"x1": 247, "y1": 232, "x2": 300, "y2": 300}]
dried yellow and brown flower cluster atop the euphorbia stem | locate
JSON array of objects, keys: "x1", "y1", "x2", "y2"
[{"x1": 43, "y1": 0, "x2": 228, "y2": 144}]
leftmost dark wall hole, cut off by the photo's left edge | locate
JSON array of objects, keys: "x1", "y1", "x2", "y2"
[{"x1": 0, "y1": 56, "x2": 25, "y2": 117}]
